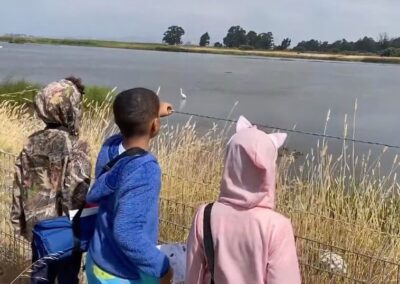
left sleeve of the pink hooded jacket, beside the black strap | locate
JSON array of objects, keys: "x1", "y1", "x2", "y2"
[{"x1": 185, "y1": 206, "x2": 206, "y2": 284}]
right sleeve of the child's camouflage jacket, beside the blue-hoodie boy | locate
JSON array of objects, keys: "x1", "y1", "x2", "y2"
[{"x1": 63, "y1": 141, "x2": 92, "y2": 210}]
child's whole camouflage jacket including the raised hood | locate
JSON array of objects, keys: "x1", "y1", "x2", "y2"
[{"x1": 11, "y1": 80, "x2": 91, "y2": 240}]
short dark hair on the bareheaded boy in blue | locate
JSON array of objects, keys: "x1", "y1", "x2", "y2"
[{"x1": 113, "y1": 88, "x2": 160, "y2": 138}]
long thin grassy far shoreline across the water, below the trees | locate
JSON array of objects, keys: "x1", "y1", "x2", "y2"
[{"x1": 0, "y1": 36, "x2": 400, "y2": 64}]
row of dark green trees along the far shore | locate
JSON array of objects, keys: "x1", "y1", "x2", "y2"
[{"x1": 163, "y1": 26, "x2": 400, "y2": 56}]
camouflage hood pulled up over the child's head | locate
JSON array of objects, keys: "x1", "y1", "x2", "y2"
[{"x1": 34, "y1": 80, "x2": 82, "y2": 135}]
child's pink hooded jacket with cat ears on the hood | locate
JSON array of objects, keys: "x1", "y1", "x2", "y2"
[{"x1": 186, "y1": 117, "x2": 301, "y2": 284}]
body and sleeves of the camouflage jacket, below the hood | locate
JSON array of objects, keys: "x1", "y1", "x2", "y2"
[{"x1": 11, "y1": 129, "x2": 91, "y2": 240}]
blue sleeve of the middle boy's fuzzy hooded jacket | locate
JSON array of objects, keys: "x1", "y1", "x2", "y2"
[{"x1": 113, "y1": 163, "x2": 169, "y2": 278}]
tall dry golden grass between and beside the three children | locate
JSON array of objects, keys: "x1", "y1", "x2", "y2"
[{"x1": 0, "y1": 97, "x2": 400, "y2": 283}]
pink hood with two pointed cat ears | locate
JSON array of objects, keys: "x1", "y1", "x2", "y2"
[{"x1": 218, "y1": 116, "x2": 287, "y2": 209}]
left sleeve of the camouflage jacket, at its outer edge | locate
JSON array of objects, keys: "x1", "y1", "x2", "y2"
[{"x1": 11, "y1": 153, "x2": 26, "y2": 235}]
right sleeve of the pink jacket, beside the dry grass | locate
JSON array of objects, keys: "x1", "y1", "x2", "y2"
[{"x1": 267, "y1": 220, "x2": 301, "y2": 284}]
